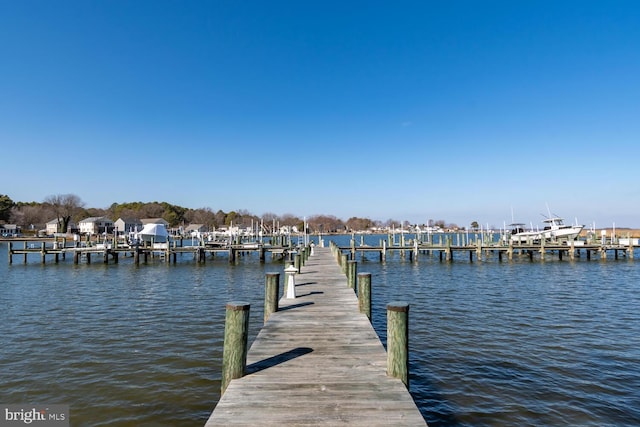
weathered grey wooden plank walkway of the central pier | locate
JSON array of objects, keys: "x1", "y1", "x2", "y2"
[{"x1": 206, "y1": 248, "x2": 426, "y2": 427}]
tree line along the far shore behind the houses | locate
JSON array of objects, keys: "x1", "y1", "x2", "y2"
[{"x1": 0, "y1": 194, "x2": 455, "y2": 233}]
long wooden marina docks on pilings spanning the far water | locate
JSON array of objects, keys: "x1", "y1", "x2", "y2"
[{"x1": 6, "y1": 234, "x2": 640, "y2": 264}]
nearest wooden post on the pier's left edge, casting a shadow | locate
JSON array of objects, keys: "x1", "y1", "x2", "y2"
[{"x1": 220, "y1": 302, "x2": 251, "y2": 395}]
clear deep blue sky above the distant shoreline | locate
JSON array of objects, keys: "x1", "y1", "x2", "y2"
[{"x1": 0, "y1": 0, "x2": 640, "y2": 227}]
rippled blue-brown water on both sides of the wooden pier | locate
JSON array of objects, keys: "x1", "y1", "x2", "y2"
[{"x1": 0, "y1": 236, "x2": 640, "y2": 426}]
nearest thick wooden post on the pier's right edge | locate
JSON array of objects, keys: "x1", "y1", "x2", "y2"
[{"x1": 387, "y1": 302, "x2": 409, "y2": 390}]
